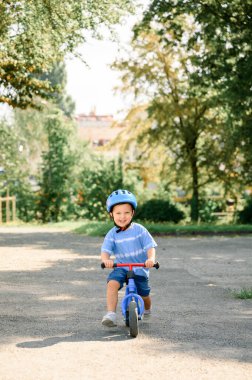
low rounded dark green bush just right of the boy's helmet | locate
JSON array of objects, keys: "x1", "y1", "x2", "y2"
[{"x1": 136, "y1": 199, "x2": 185, "y2": 223}]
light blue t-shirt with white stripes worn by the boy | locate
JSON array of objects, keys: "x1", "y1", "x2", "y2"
[{"x1": 101, "y1": 223, "x2": 157, "y2": 278}]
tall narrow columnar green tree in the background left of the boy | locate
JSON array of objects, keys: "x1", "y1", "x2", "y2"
[{"x1": 38, "y1": 110, "x2": 75, "y2": 223}]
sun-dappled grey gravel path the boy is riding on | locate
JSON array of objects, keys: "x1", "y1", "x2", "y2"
[{"x1": 0, "y1": 228, "x2": 252, "y2": 380}]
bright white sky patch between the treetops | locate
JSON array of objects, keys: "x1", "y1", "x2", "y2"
[{"x1": 66, "y1": 0, "x2": 152, "y2": 117}]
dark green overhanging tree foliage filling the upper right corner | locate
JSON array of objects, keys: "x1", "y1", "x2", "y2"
[{"x1": 140, "y1": 0, "x2": 252, "y2": 184}]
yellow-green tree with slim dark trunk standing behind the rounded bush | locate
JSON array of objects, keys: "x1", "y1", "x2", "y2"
[{"x1": 112, "y1": 26, "x2": 234, "y2": 220}]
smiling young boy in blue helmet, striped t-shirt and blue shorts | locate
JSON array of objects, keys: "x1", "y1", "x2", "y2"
[{"x1": 101, "y1": 189, "x2": 157, "y2": 327}]
